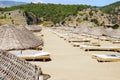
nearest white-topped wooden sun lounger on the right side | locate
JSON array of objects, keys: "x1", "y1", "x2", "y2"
[{"x1": 92, "y1": 54, "x2": 120, "y2": 62}]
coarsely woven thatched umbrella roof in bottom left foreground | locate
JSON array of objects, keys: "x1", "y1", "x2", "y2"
[{"x1": 0, "y1": 50, "x2": 43, "y2": 80}]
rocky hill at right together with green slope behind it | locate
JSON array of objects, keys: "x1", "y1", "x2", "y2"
[{"x1": 62, "y1": 1, "x2": 120, "y2": 29}]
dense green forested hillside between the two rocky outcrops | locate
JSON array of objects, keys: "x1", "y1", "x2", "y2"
[{"x1": 0, "y1": 3, "x2": 91, "y2": 23}]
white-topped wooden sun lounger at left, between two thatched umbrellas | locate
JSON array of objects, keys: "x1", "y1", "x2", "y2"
[{"x1": 10, "y1": 50, "x2": 50, "y2": 61}]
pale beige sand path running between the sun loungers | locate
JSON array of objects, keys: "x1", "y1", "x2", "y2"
[{"x1": 31, "y1": 28, "x2": 120, "y2": 80}]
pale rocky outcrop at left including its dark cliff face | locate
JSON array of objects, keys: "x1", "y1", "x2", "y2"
[{"x1": 0, "y1": 9, "x2": 38, "y2": 25}]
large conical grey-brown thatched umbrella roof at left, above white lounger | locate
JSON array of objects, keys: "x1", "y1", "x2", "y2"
[{"x1": 0, "y1": 25, "x2": 42, "y2": 50}]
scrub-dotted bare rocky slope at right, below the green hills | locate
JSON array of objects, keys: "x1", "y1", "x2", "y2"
[{"x1": 61, "y1": 8, "x2": 120, "y2": 27}]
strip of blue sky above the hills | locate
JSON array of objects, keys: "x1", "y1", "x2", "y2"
[{"x1": 0, "y1": 0, "x2": 120, "y2": 6}]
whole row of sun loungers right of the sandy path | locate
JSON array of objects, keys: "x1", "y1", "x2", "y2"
[{"x1": 51, "y1": 27, "x2": 120, "y2": 62}]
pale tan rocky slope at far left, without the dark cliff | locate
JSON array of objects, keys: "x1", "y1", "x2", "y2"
[{"x1": 0, "y1": 9, "x2": 27, "y2": 25}]
